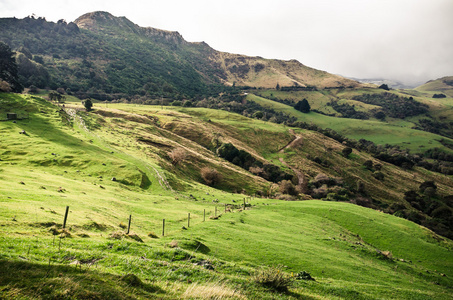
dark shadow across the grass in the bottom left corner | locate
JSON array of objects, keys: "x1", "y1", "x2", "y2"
[{"x1": 0, "y1": 260, "x2": 165, "y2": 299}]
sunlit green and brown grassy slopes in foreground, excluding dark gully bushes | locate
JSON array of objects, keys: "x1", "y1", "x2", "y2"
[{"x1": 0, "y1": 94, "x2": 453, "y2": 299}]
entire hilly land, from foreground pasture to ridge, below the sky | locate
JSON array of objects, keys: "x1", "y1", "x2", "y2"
[{"x1": 0, "y1": 12, "x2": 453, "y2": 299}]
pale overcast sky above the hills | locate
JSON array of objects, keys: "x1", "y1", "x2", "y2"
[{"x1": 0, "y1": 0, "x2": 453, "y2": 84}]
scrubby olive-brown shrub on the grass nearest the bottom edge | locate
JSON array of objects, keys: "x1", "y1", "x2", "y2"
[{"x1": 252, "y1": 266, "x2": 294, "y2": 292}]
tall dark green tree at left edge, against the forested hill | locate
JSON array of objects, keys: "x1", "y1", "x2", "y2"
[{"x1": 0, "y1": 42, "x2": 24, "y2": 93}]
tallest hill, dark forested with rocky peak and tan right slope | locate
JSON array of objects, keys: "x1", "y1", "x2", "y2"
[{"x1": 0, "y1": 12, "x2": 360, "y2": 100}]
